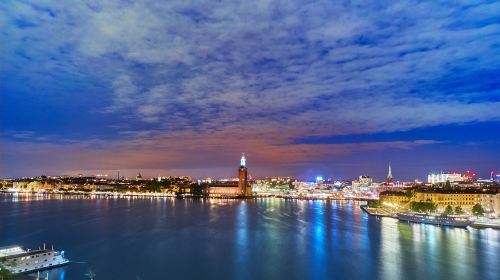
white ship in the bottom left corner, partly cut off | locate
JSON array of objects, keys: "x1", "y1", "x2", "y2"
[{"x1": 0, "y1": 244, "x2": 69, "y2": 273}]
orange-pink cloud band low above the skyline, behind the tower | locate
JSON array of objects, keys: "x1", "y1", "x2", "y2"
[{"x1": 0, "y1": 124, "x2": 442, "y2": 176}]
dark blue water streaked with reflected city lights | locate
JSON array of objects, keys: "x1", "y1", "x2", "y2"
[{"x1": 0, "y1": 194, "x2": 500, "y2": 280}]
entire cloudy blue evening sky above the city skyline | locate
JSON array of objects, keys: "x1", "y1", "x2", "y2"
[{"x1": 0, "y1": 0, "x2": 500, "y2": 180}]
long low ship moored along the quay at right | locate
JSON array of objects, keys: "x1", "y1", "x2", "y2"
[{"x1": 397, "y1": 212, "x2": 474, "y2": 227}]
